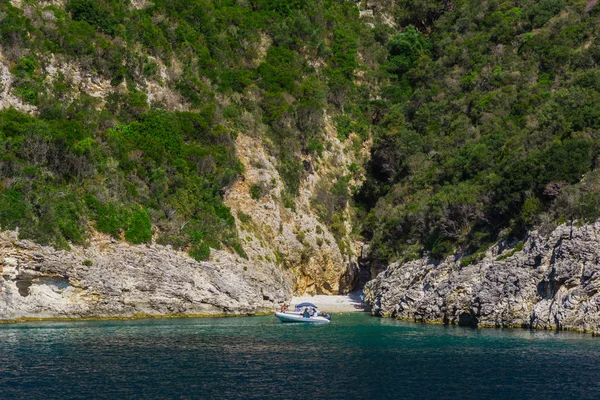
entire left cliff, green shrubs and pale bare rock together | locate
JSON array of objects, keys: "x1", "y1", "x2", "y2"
[{"x1": 0, "y1": 0, "x2": 381, "y2": 318}]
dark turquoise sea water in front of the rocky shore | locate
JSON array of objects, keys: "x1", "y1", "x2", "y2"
[{"x1": 0, "y1": 314, "x2": 600, "y2": 399}]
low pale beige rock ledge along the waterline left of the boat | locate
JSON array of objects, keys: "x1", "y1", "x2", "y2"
[{"x1": 0, "y1": 232, "x2": 293, "y2": 321}]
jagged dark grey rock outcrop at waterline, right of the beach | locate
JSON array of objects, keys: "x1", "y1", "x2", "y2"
[{"x1": 365, "y1": 223, "x2": 600, "y2": 333}]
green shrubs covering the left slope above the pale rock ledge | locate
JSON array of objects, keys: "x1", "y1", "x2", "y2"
[{"x1": 0, "y1": 0, "x2": 382, "y2": 260}]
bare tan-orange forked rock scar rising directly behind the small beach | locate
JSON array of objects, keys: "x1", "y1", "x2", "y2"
[{"x1": 224, "y1": 133, "x2": 360, "y2": 294}]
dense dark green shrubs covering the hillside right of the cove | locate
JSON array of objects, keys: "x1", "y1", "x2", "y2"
[{"x1": 357, "y1": 0, "x2": 600, "y2": 264}]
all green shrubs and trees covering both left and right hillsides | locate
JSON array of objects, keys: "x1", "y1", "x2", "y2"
[{"x1": 0, "y1": 0, "x2": 600, "y2": 264}]
